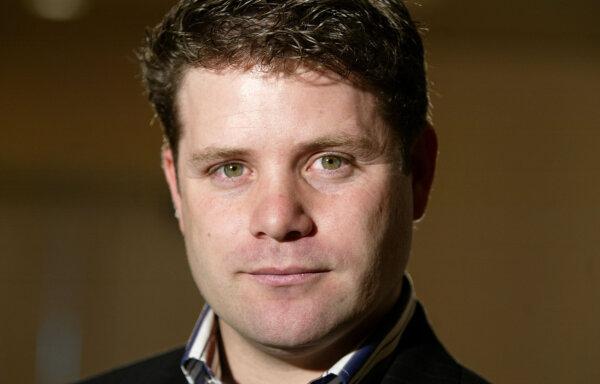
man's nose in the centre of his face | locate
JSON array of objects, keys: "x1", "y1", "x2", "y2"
[{"x1": 250, "y1": 178, "x2": 315, "y2": 242}]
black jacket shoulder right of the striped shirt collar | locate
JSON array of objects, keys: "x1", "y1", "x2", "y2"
[{"x1": 366, "y1": 304, "x2": 488, "y2": 384}]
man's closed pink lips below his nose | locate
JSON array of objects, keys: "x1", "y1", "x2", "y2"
[{"x1": 248, "y1": 267, "x2": 330, "y2": 287}]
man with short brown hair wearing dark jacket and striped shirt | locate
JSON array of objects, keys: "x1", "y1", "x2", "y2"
[{"x1": 79, "y1": 0, "x2": 484, "y2": 384}]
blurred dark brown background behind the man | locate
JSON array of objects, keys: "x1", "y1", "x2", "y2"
[{"x1": 0, "y1": 0, "x2": 600, "y2": 384}]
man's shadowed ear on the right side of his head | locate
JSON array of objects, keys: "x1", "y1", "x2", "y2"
[{"x1": 411, "y1": 123, "x2": 438, "y2": 220}]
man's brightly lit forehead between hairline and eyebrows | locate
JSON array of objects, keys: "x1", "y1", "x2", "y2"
[{"x1": 177, "y1": 68, "x2": 389, "y2": 149}]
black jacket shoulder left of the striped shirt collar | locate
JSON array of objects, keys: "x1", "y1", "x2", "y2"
[{"x1": 78, "y1": 348, "x2": 187, "y2": 384}]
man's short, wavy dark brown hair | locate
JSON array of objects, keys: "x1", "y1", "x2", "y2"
[{"x1": 138, "y1": 0, "x2": 428, "y2": 167}]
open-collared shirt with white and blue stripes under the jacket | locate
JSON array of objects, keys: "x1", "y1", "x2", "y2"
[{"x1": 181, "y1": 274, "x2": 416, "y2": 384}]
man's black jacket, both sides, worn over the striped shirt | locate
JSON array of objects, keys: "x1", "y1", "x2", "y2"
[{"x1": 80, "y1": 304, "x2": 487, "y2": 384}]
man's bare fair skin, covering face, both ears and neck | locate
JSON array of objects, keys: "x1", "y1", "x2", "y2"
[{"x1": 163, "y1": 68, "x2": 437, "y2": 383}]
